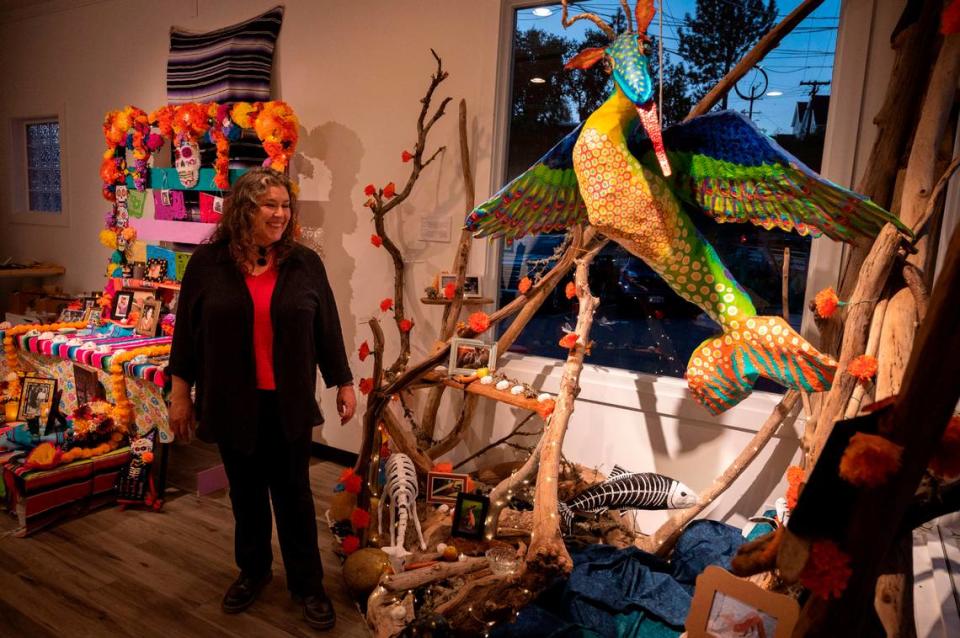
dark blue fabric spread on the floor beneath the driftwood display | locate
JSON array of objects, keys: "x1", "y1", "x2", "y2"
[{"x1": 491, "y1": 521, "x2": 745, "y2": 638}]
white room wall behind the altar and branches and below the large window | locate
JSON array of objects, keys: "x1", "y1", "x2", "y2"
[{"x1": 0, "y1": 0, "x2": 902, "y2": 527}]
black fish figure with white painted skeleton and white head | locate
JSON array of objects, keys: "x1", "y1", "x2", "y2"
[{"x1": 560, "y1": 465, "x2": 698, "y2": 531}]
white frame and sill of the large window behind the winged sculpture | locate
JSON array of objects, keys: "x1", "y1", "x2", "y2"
[{"x1": 484, "y1": 0, "x2": 877, "y2": 430}]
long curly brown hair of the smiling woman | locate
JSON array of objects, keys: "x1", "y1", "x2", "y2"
[{"x1": 210, "y1": 167, "x2": 298, "y2": 272}]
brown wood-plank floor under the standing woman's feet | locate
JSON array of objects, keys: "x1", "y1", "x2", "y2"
[{"x1": 0, "y1": 446, "x2": 369, "y2": 638}]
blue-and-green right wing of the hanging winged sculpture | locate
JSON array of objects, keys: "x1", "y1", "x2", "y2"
[{"x1": 628, "y1": 111, "x2": 910, "y2": 242}]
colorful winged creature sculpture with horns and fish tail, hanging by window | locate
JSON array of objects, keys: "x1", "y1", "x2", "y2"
[{"x1": 466, "y1": 0, "x2": 909, "y2": 414}]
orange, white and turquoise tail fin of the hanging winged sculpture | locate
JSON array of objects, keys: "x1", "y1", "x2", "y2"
[{"x1": 686, "y1": 316, "x2": 837, "y2": 414}]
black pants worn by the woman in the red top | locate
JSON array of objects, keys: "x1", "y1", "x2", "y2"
[{"x1": 219, "y1": 390, "x2": 323, "y2": 595}]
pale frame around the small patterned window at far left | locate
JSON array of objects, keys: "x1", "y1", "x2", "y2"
[{"x1": 8, "y1": 105, "x2": 70, "y2": 226}]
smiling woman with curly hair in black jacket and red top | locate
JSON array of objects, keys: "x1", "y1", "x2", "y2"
[{"x1": 168, "y1": 168, "x2": 356, "y2": 629}]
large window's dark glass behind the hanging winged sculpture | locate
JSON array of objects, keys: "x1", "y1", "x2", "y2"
[{"x1": 499, "y1": 0, "x2": 839, "y2": 389}]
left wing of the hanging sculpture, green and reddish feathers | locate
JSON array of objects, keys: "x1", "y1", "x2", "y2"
[{"x1": 466, "y1": 125, "x2": 587, "y2": 239}]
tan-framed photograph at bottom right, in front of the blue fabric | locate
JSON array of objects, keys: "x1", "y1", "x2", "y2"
[{"x1": 688, "y1": 568, "x2": 800, "y2": 638}]
